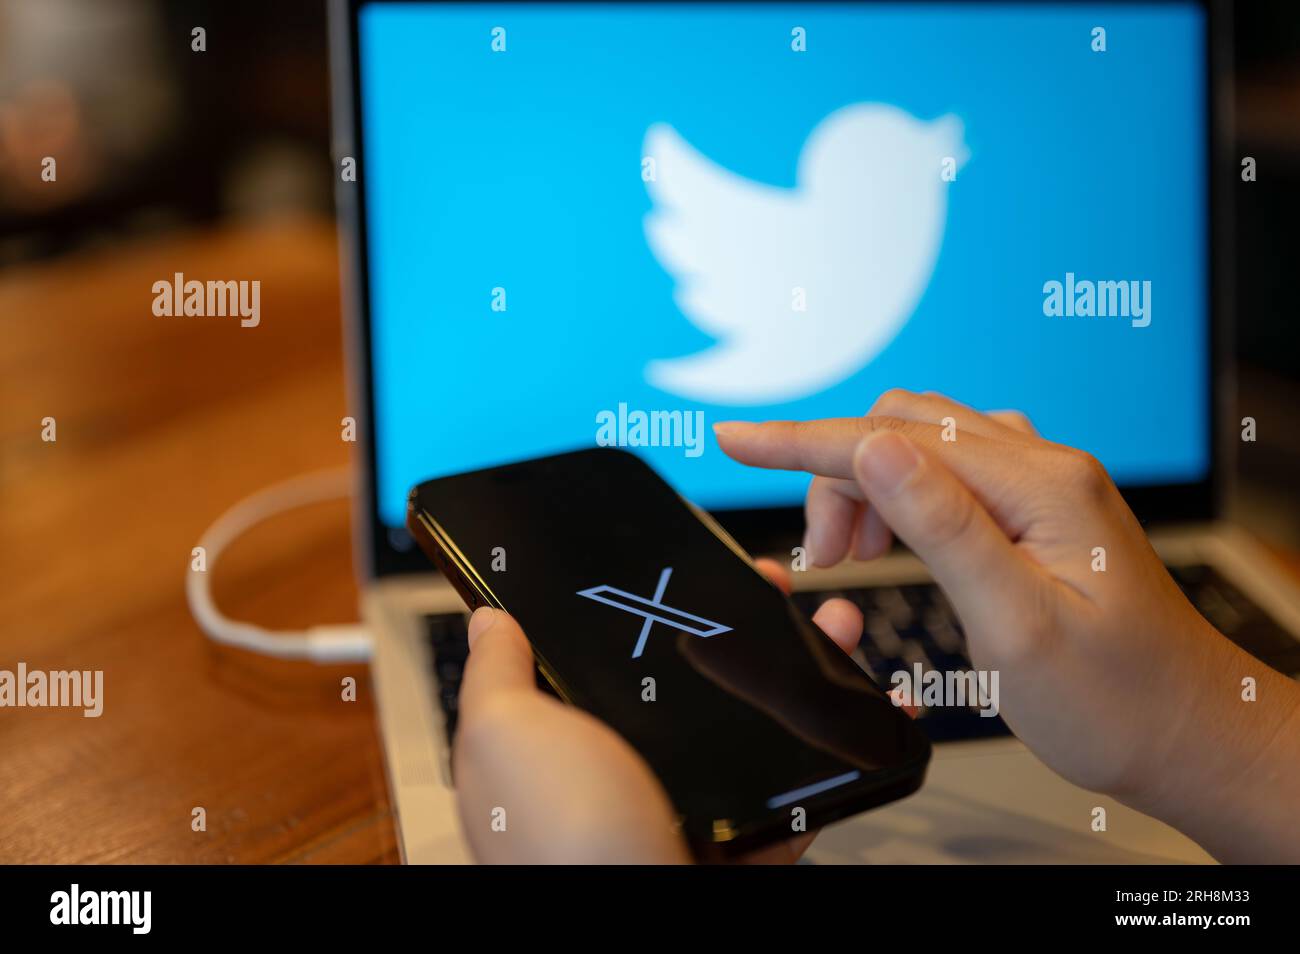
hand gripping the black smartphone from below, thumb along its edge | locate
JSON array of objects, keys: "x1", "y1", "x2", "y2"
[{"x1": 452, "y1": 561, "x2": 862, "y2": 864}]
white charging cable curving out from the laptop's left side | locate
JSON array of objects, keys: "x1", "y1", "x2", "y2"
[{"x1": 185, "y1": 468, "x2": 373, "y2": 663}]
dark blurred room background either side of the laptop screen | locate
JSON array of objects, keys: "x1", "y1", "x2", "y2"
[{"x1": 0, "y1": 0, "x2": 1300, "y2": 545}]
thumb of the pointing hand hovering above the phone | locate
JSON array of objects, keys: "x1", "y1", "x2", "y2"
[{"x1": 853, "y1": 430, "x2": 1039, "y2": 632}]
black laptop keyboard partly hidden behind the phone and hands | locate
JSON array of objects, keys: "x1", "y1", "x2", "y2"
[{"x1": 424, "y1": 565, "x2": 1300, "y2": 743}]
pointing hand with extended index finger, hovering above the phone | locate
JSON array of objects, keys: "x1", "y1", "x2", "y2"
[{"x1": 715, "y1": 391, "x2": 1300, "y2": 860}]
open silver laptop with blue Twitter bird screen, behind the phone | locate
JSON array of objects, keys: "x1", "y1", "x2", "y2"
[{"x1": 332, "y1": 0, "x2": 1300, "y2": 863}]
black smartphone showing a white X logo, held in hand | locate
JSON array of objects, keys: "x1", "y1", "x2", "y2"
[{"x1": 407, "y1": 448, "x2": 930, "y2": 858}]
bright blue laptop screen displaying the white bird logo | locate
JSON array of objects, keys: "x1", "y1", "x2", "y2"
[{"x1": 358, "y1": 3, "x2": 1210, "y2": 526}]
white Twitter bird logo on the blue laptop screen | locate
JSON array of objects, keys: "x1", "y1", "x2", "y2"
[{"x1": 642, "y1": 103, "x2": 966, "y2": 404}]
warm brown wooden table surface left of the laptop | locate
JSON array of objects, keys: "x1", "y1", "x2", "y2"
[{"x1": 0, "y1": 221, "x2": 397, "y2": 863}]
